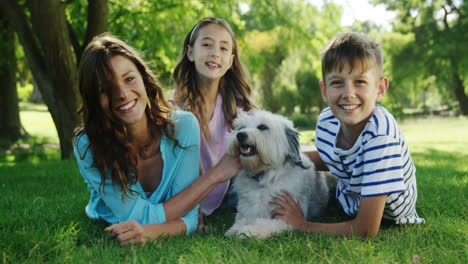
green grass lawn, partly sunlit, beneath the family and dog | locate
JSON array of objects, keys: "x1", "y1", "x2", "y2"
[{"x1": 0, "y1": 107, "x2": 468, "y2": 263}]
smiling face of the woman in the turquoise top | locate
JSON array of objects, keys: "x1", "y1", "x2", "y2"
[{"x1": 100, "y1": 55, "x2": 148, "y2": 125}]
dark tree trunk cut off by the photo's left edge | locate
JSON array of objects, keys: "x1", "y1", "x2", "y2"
[{"x1": 0, "y1": 13, "x2": 26, "y2": 142}]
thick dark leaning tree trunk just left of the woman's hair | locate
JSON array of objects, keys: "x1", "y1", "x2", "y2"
[{"x1": 27, "y1": 0, "x2": 79, "y2": 159}]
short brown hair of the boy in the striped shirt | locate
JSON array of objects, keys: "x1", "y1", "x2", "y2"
[{"x1": 321, "y1": 32, "x2": 383, "y2": 85}]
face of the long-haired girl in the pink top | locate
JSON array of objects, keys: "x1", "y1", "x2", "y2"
[{"x1": 187, "y1": 24, "x2": 234, "y2": 81}]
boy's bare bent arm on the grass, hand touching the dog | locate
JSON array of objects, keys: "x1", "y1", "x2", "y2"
[{"x1": 273, "y1": 193, "x2": 387, "y2": 239}]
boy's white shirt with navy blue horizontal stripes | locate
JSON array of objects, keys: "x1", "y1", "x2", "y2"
[{"x1": 315, "y1": 105, "x2": 424, "y2": 224}]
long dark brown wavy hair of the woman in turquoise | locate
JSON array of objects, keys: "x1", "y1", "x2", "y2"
[{"x1": 75, "y1": 33, "x2": 178, "y2": 199}]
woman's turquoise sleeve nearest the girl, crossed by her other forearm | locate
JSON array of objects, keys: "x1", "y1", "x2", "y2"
[{"x1": 165, "y1": 111, "x2": 200, "y2": 235}]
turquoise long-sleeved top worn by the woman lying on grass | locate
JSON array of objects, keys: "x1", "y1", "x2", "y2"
[{"x1": 74, "y1": 111, "x2": 200, "y2": 235}]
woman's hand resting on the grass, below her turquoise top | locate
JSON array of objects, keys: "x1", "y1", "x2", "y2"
[{"x1": 104, "y1": 220, "x2": 147, "y2": 246}]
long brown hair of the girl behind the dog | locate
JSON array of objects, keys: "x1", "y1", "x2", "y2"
[{"x1": 173, "y1": 17, "x2": 254, "y2": 137}]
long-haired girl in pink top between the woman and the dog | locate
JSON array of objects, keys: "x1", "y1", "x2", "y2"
[{"x1": 174, "y1": 17, "x2": 253, "y2": 219}]
